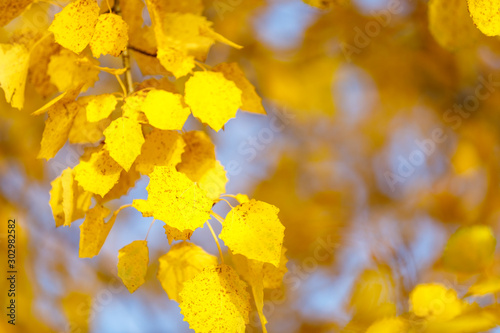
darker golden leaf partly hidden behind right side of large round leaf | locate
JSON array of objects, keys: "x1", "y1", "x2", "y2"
[{"x1": 212, "y1": 62, "x2": 266, "y2": 114}]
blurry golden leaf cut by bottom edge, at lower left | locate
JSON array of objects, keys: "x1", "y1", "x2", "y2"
[{"x1": 61, "y1": 292, "x2": 92, "y2": 333}]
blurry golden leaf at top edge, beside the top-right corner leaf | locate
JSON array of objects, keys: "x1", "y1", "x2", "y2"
[{"x1": 428, "y1": 0, "x2": 480, "y2": 51}]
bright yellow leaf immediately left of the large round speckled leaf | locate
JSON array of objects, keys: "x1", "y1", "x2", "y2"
[{"x1": 142, "y1": 89, "x2": 191, "y2": 130}]
